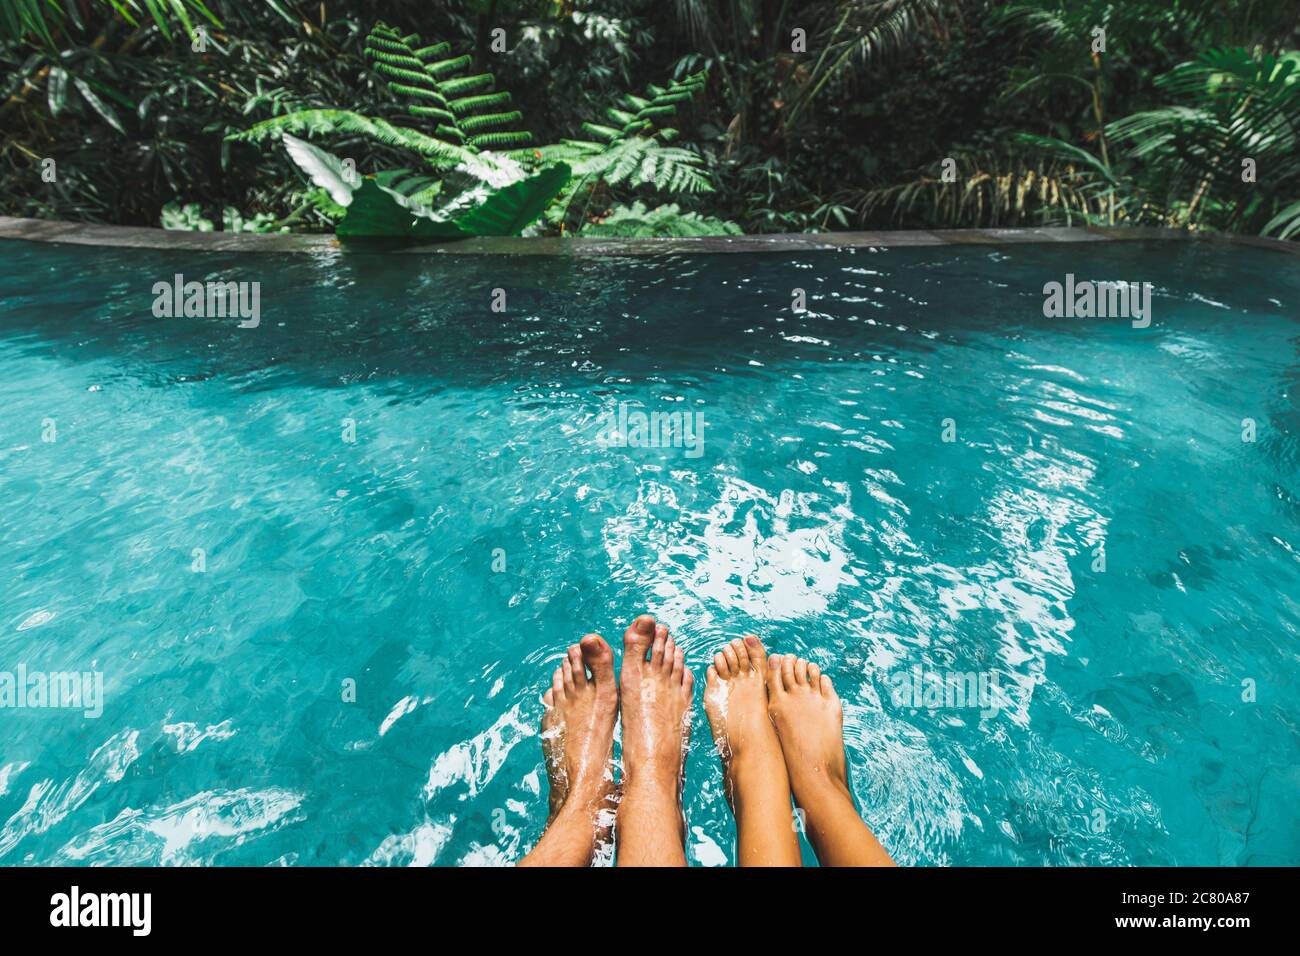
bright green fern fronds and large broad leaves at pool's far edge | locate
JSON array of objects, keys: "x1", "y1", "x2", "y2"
[{"x1": 229, "y1": 22, "x2": 733, "y2": 239}]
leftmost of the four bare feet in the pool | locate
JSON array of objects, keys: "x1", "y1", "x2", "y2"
[{"x1": 520, "y1": 633, "x2": 619, "y2": 866}]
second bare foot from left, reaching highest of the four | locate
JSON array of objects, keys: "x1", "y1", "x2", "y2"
[{"x1": 618, "y1": 614, "x2": 696, "y2": 866}]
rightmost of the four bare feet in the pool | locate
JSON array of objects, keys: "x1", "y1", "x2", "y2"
[{"x1": 767, "y1": 654, "x2": 893, "y2": 866}]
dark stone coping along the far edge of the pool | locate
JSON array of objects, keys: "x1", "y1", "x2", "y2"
[{"x1": 0, "y1": 216, "x2": 1300, "y2": 256}]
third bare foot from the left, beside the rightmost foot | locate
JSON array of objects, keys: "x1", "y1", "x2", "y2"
[{"x1": 705, "y1": 635, "x2": 800, "y2": 866}]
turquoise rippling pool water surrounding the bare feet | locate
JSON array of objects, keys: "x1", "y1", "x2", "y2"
[{"x1": 0, "y1": 241, "x2": 1300, "y2": 865}]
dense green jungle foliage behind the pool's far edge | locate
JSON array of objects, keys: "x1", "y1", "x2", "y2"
[{"x1": 0, "y1": 0, "x2": 1300, "y2": 239}]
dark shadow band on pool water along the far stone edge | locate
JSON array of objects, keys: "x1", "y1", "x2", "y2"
[{"x1": 0, "y1": 242, "x2": 1300, "y2": 390}]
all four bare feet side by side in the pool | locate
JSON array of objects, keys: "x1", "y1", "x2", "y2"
[{"x1": 521, "y1": 614, "x2": 891, "y2": 866}]
